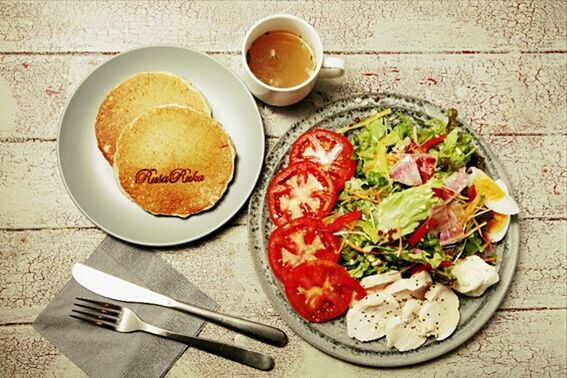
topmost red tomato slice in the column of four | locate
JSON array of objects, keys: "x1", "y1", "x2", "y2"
[{"x1": 289, "y1": 129, "x2": 356, "y2": 190}]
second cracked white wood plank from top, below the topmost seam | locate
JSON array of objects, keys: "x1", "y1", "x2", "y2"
[{"x1": 0, "y1": 54, "x2": 567, "y2": 140}]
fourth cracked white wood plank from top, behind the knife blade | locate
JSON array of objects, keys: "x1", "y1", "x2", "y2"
[{"x1": 0, "y1": 220, "x2": 567, "y2": 325}]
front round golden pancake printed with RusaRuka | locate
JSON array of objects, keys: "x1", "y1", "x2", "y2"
[{"x1": 113, "y1": 105, "x2": 236, "y2": 218}]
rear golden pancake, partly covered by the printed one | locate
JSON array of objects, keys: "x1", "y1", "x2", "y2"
[{"x1": 95, "y1": 72, "x2": 211, "y2": 165}]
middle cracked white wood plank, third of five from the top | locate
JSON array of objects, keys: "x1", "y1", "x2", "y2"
[{"x1": 0, "y1": 135, "x2": 567, "y2": 228}]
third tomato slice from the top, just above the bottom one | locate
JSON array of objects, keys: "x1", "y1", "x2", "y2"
[{"x1": 268, "y1": 217, "x2": 339, "y2": 283}]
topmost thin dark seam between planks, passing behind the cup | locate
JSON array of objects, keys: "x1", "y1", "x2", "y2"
[{"x1": 0, "y1": 46, "x2": 567, "y2": 56}]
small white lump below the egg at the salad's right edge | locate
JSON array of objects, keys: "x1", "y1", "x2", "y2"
[{"x1": 452, "y1": 255, "x2": 499, "y2": 297}]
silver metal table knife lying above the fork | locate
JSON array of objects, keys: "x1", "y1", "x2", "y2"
[{"x1": 72, "y1": 264, "x2": 287, "y2": 347}]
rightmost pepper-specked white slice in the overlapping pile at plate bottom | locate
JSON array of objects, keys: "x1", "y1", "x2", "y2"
[{"x1": 417, "y1": 283, "x2": 460, "y2": 340}]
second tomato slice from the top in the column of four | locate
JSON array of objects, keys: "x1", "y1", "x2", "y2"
[{"x1": 268, "y1": 161, "x2": 337, "y2": 226}]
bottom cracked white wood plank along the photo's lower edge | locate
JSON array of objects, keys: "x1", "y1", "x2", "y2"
[{"x1": 0, "y1": 310, "x2": 567, "y2": 378}]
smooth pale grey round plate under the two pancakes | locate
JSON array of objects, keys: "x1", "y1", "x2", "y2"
[{"x1": 58, "y1": 46, "x2": 264, "y2": 246}]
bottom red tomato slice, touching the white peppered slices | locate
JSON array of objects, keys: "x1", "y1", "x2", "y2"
[{"x1": 285, "y1": 260, "x2": 366, "y2": 323}]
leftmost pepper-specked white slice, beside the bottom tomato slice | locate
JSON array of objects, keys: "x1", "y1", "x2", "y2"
[{"x1": 346, "y1": 293, "x2": 401, "y2": 341}]
